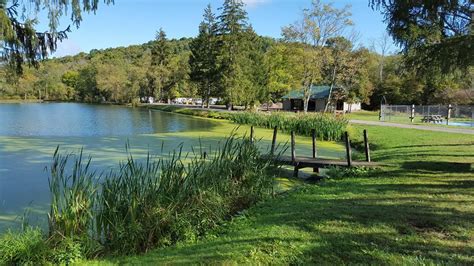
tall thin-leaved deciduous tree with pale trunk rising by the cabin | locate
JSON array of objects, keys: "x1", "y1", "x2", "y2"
[{"x1": 282, "y1": 0, "x2": 352, "y2": 112}]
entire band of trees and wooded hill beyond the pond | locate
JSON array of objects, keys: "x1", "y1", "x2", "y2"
[{"x1": 0, "y1": 1, "x2": 474, "y2": 108}]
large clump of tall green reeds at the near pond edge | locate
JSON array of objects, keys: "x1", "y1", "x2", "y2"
[{"x1": 49, "y1": 135, "x2": 278, "y2": 254}]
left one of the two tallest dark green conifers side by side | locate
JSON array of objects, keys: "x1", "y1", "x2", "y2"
[{"x1": 189, "y1": 4, "x2": 219, "y2": 108}]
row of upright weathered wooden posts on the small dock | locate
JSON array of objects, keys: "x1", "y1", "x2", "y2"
[{"x1": 256, "y1": 126, "x2": 371, "y2": 167}]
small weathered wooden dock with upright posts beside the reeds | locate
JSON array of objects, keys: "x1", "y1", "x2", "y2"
[{"x1": 262, "y1": 126, "x2": 380, "y2": 177}]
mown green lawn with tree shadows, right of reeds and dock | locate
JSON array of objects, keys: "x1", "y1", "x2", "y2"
[{"x1": 88, "y1": 126, "x2": 474, "y2": 265}]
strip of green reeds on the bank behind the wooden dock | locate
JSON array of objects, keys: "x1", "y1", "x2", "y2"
[{"x1": 229, "y1": 112, "x2": 348, "y2": 141}]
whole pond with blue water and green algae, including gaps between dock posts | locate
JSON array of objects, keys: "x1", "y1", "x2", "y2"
[{"x1": 0, "y1": 103, "x2": 344, "y2": 231}]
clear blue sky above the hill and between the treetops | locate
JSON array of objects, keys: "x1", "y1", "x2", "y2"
[{"x1": 45, "y1": 0, "x2": 396, "y2": 56}]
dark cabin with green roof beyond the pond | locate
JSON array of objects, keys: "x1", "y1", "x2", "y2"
[{"x1": 283, "y1": 85, "x2": 361, "y2": 113}]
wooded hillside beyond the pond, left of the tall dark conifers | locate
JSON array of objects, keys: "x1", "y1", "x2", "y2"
[{"x1": 0, "y1": 38, "x2": 193, "y2": 103}]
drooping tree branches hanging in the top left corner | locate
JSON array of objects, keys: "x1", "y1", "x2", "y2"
[{"x1": 0, "y1": 0, "x2": 114, "y2": 73}]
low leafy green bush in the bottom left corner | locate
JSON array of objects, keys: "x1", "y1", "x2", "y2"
[{"x1": 0, "y1": 227, "x2": 50, "y2": 265}]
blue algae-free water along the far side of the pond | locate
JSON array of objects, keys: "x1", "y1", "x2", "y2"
[{"x1": 0, "y1": 103, "x2": 215, "y2": 137}]
